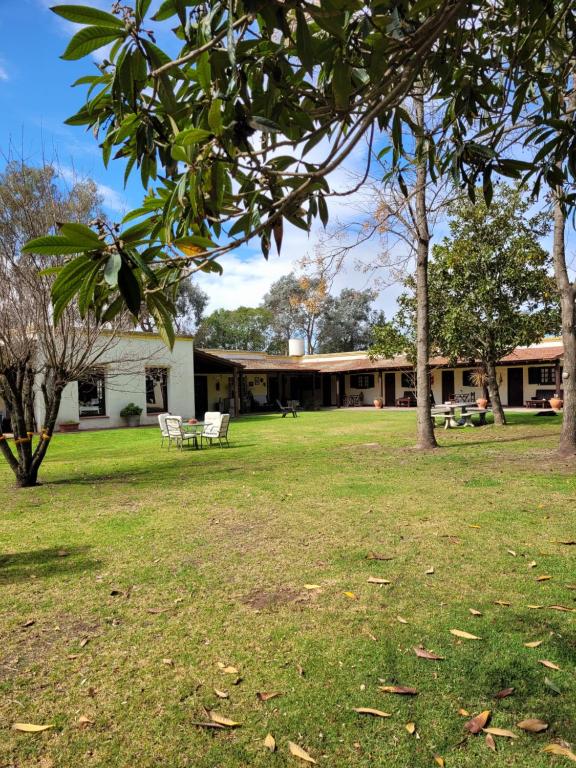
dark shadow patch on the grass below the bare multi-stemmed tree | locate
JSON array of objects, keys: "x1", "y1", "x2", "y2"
[{"x1": 0, "y1": 547, "x2": 101, "y2": 585}]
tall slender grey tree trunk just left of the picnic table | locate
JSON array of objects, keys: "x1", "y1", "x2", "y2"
[{"x1": 414, "y1": 86, "x2": 438, "y2": 450}]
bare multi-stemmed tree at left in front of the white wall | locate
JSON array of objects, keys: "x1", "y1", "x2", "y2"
[{"x1": 0, "y1": 161, "x2": 120, "y2": 487}]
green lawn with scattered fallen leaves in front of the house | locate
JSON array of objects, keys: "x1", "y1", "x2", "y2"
[{"x1": 0, "y1": 410, "x2": 576, "y2": 768}]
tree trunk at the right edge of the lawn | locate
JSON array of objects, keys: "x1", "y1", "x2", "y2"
[{"x1": 553, "y1": 195, "x2": 576, "y2": 456}]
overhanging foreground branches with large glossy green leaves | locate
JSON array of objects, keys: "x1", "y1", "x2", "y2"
[{"x1": 23, "y1": 0, "x2": 576, "y2": 342}]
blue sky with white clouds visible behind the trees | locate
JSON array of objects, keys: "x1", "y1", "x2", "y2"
[{"x1": 0, "y1": 0, "x2": 408, "y2": 315}]
